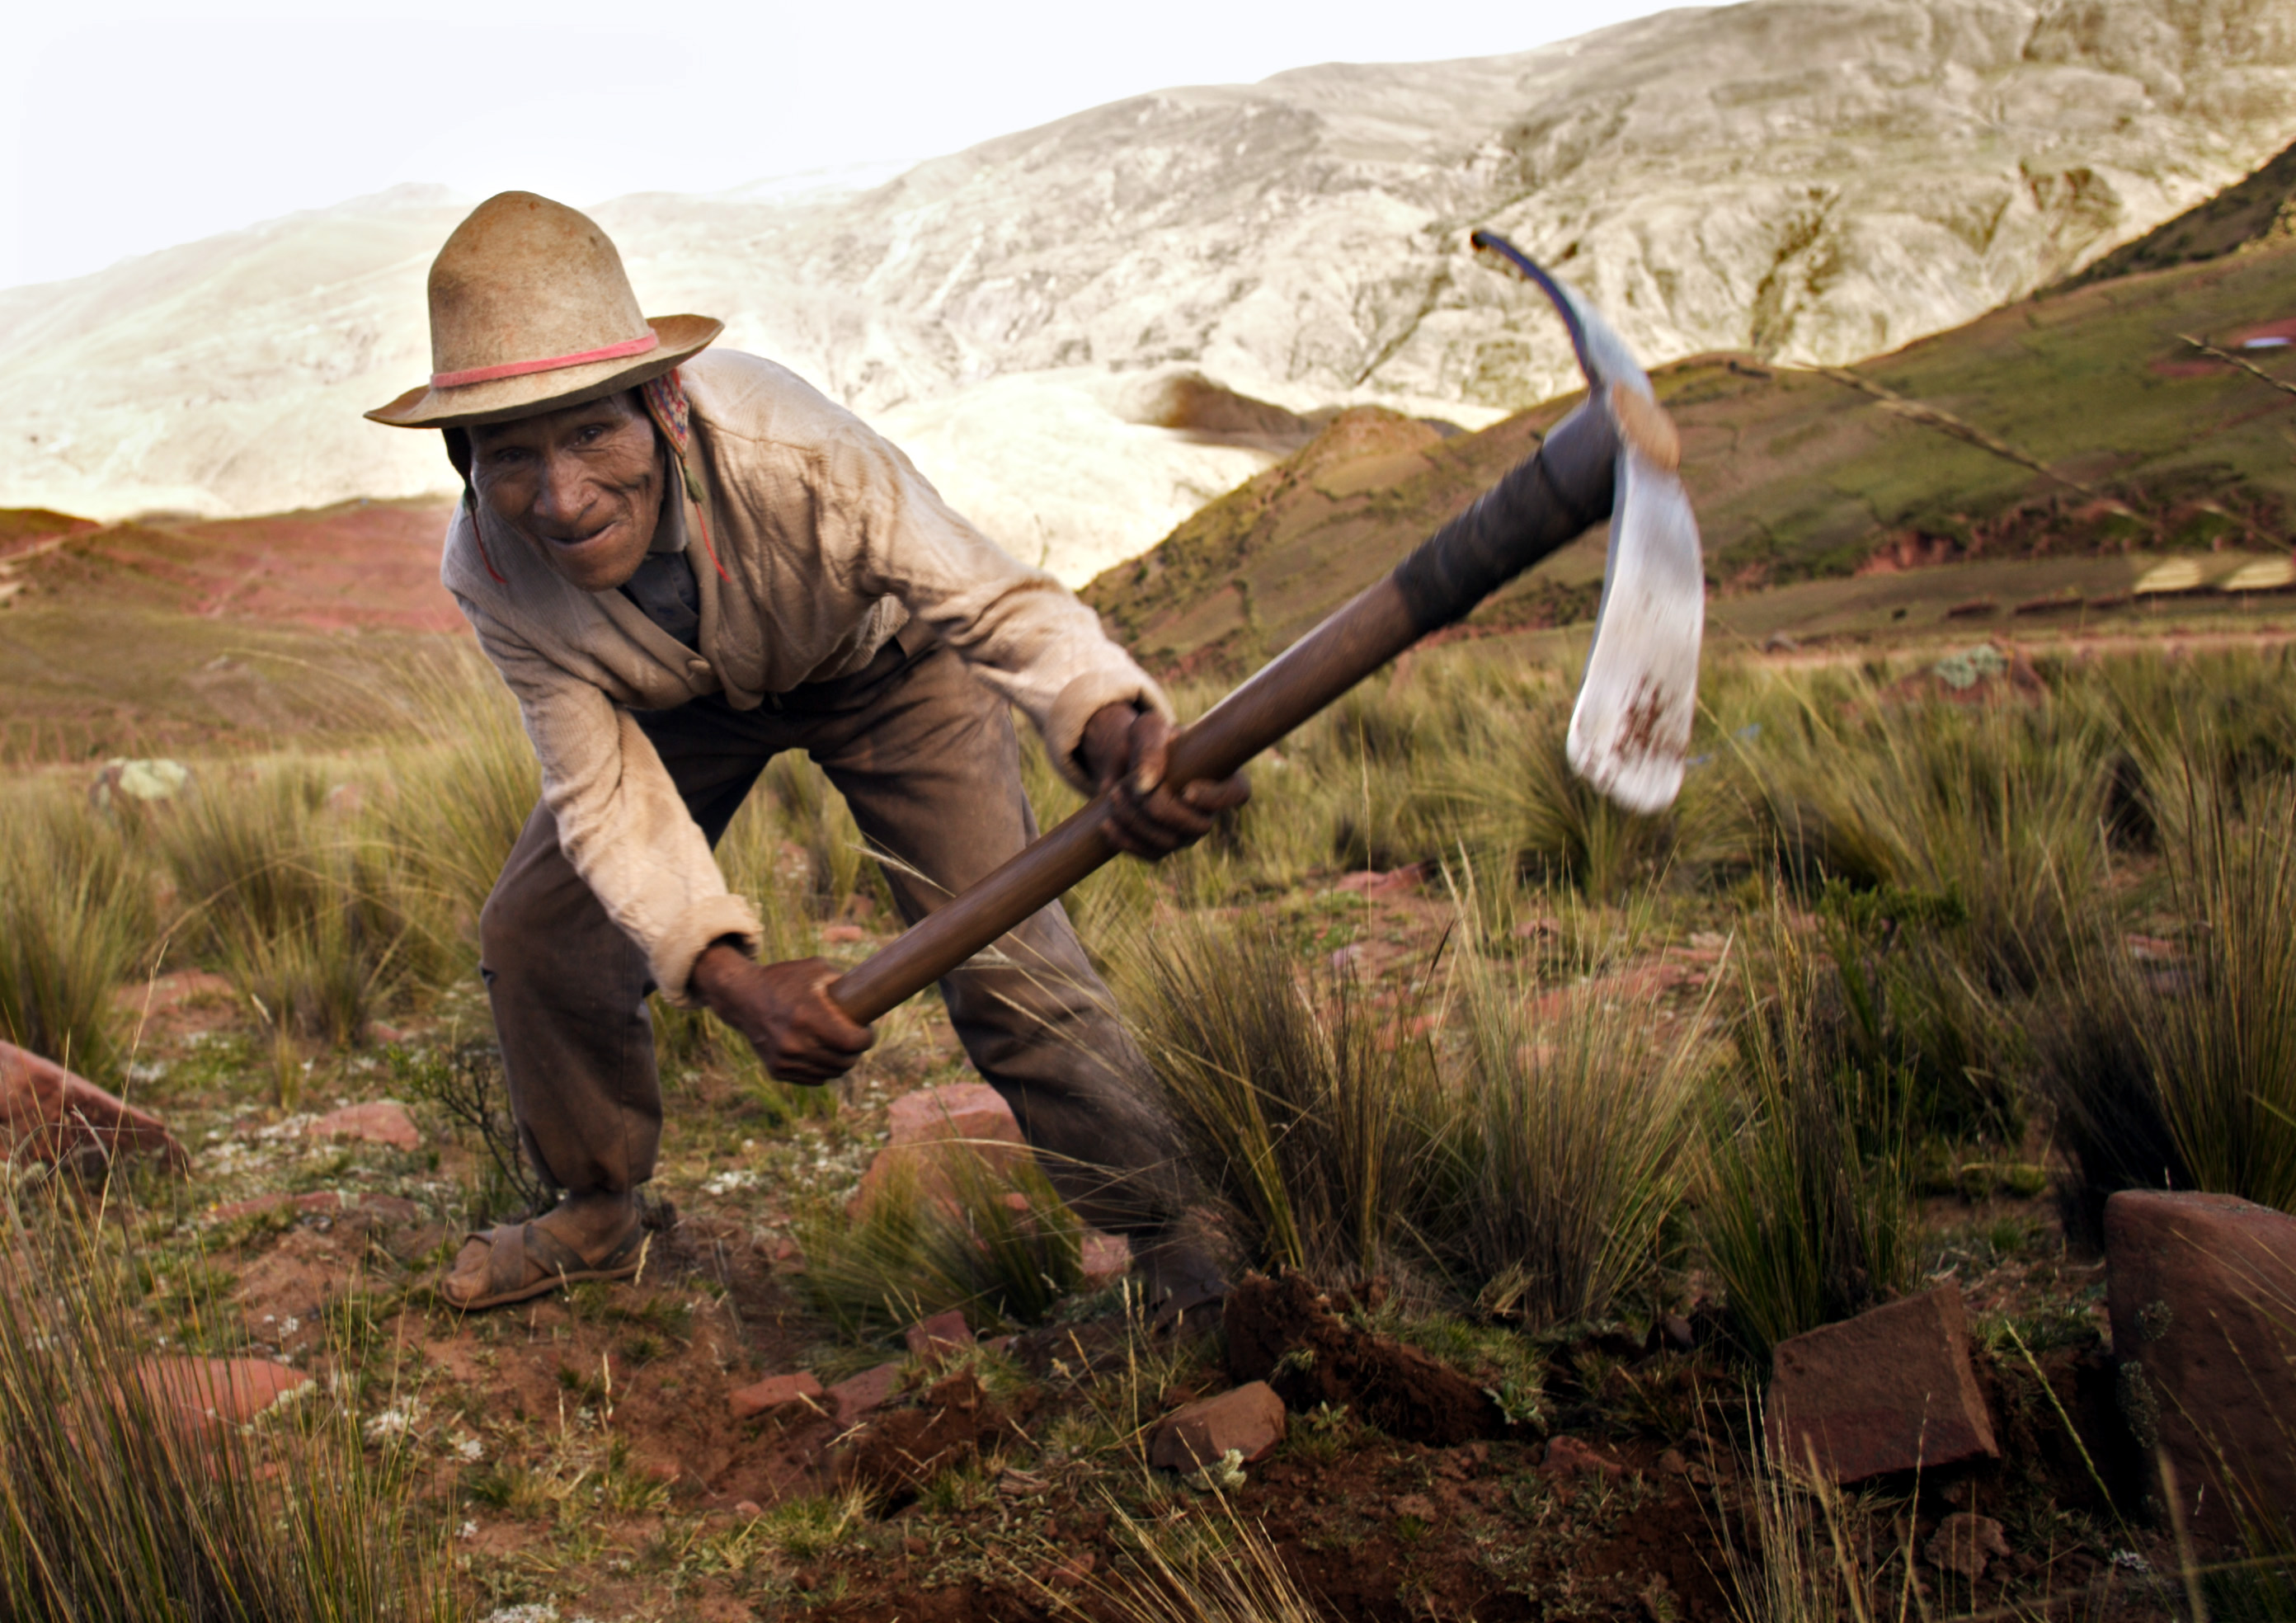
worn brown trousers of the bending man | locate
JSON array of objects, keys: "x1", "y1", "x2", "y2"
[{"x1": 466, "y1": 638, "x2": 1183, "y2": 1237}]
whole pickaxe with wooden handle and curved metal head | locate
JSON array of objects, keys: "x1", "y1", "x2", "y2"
[{"x1": 829, "y1": 232, "x2": 1706, "y2": 1023}]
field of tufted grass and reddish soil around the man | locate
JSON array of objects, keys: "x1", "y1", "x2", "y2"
[{"x1": 0, "y1": 642, "x2": 2296, "y2": 1618}]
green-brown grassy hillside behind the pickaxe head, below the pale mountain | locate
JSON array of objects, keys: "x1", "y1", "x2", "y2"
[{"x1": 1086, "y1": 223, "x2": 2296, "y2": 673}]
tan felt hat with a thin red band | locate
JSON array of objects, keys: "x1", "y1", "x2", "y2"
[{"x1": 367, "y1": 191, "x2": 726, "y2": 430}]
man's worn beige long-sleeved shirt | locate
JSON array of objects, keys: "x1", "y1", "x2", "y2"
[{"x1": 441, "y1": 349, "x2": 1171, "y2": 1001}]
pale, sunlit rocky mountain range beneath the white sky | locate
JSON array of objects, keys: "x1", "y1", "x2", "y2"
[{"x1": 0, "y1": 0, "x2": 2296, "y2": 581}]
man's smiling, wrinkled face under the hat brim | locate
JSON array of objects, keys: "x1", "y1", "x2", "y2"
[{"x1": 471, "y1": 390, "x2": 666, "y2": 592}]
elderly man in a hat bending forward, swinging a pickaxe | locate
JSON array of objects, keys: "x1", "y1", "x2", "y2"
[{"x1": 367, "y1": 193, "x2": 1247, "y2": 1309}]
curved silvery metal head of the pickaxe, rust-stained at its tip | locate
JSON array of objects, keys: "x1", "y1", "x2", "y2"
[{"x1": 1470, "y1": 232, "x2": 1706, "y2": 812}]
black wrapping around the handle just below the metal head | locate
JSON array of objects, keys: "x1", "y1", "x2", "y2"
[{"x1": 1394, "y1": 402, "x2": 1619, "y2": 633}]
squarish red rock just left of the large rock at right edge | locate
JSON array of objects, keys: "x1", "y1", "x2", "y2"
[{"x1": 1766, "y1": 1281, "x2": 2000, "y2": 1483}]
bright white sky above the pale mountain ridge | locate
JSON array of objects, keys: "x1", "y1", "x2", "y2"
[{"x1": 0, "y1": 0, "x2": 1667, "y2": 287}]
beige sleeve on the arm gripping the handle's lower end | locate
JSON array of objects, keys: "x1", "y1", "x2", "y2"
[{"x1": 463, "y1": 601, "x2": 762, "y2": 1008}]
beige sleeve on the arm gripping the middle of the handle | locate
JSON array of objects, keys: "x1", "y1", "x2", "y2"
[{"x1": 817, "y1": 422, "x2": 1174, "y2": 790}]
